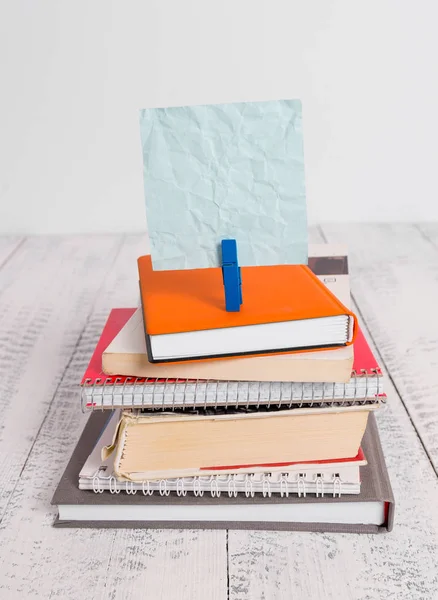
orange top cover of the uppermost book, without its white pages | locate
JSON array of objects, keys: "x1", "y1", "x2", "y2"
[{"x1": 138, "y1": 255, "x2": 357, "y2": 338}]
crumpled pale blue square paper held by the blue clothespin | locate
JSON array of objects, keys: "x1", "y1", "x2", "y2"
[{"x1": 140, "y1": 100, "x2": 307, "y2": 270}]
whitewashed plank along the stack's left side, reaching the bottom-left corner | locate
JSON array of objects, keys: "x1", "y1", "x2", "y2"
[{"x1": 0, "y1": 236, "x2": 227, "y2": 600}]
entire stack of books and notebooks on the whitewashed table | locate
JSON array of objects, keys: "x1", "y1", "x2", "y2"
[{"x1": 53, "y1": 245, "x2": 394, "y2": 533}]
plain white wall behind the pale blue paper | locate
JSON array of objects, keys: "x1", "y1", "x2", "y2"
[{"x1": 0, "y1": 0, "x2": 438, "y2": 233}]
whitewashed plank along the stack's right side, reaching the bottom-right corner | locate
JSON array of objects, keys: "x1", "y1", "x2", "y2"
[{"x1": 228, "y1": 310, "x2": 438, "y2": 600}]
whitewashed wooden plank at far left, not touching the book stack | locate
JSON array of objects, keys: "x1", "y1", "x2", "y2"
[{"x1": 0, "y1": 236, "x2": 121, "y2": 518}]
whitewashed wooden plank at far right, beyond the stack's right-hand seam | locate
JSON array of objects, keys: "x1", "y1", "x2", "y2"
[{"x1": 324, "y1": 224, "x2": 438, "y2": 473}]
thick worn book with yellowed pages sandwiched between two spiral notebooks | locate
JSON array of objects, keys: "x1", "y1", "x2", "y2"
[{"x1": 102, "y1": 406, "x2": 369, "y2": 481}]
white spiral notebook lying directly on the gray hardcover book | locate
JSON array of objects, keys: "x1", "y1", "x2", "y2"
[{"x1": 79, "y1": 411, "x2": 366, "y2": 497}]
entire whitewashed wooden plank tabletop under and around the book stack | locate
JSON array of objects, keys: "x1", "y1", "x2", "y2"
[{"x1": 0, "y1": 224, "x2": 438, "y2": 600}]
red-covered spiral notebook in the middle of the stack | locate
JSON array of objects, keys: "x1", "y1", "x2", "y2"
[{"x1": 81, "y1": 308, "x2": 385, "y2": 409}]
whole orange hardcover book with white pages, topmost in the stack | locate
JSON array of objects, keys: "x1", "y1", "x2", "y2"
[{"x1": 138, "y1": 255, "x2": 356, "y2": 362}]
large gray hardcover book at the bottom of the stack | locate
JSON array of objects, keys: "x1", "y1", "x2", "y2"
[{"x1": 52, "y1": 412, "x2": 394, "y2": 533}]
